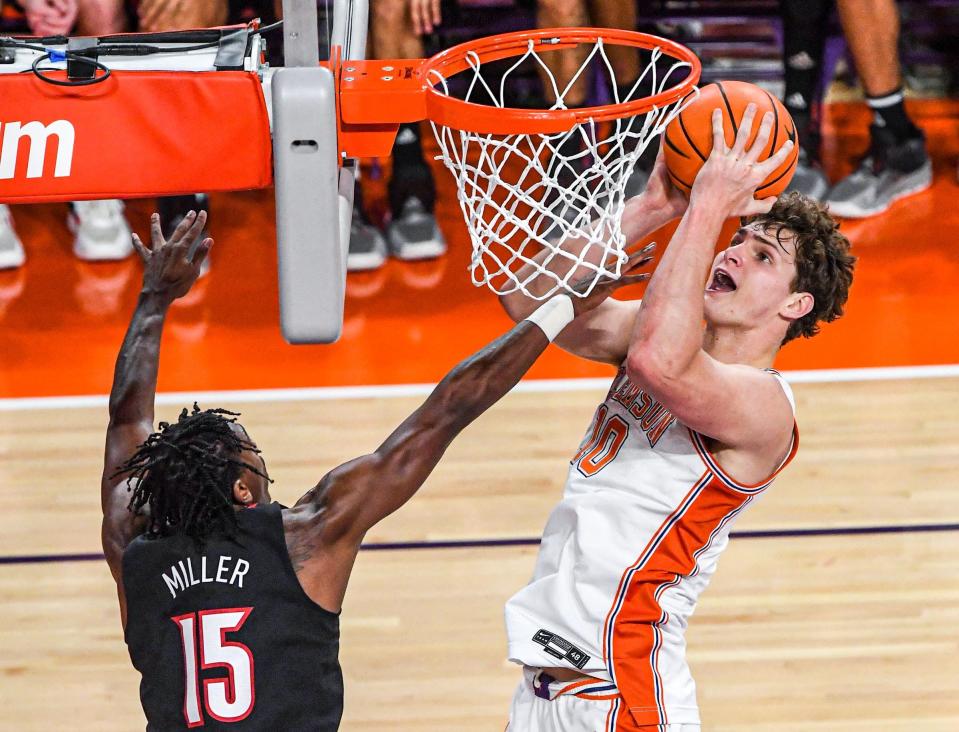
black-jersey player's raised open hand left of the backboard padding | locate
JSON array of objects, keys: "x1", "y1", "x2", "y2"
[{"x1": 133, "y1": 211, "x2": 213, "y2": 302}]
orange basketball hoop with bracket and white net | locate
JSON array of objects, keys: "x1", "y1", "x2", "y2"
[{"x1": 340, "y1": 28, "x2": 701, "y2": 299}]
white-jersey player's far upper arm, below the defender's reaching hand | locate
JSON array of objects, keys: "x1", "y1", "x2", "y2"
[{"x1": 554, "y1": 298, "x2": 642, "y2": 366}]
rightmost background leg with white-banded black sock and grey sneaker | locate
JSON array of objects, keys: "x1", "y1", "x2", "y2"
[{"x1": 828, "y1": 0, "x2": 932, "y2": 218}]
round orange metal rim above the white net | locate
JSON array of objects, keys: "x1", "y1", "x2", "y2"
[{"x1": 419, "y1": 28, "x2": 702, "y2": 135}]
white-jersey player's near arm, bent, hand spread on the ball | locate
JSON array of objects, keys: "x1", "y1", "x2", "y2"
[{"x1": 627, "y1": 104, "x2": 793, "y2": 458}]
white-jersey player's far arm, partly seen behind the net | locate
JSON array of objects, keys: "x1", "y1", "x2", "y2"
[{"x1": 500, "y1": 151, "x2": 686, "y2": 366}]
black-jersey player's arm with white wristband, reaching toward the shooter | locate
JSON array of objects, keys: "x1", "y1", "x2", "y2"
[{"x1": 286, "y1": 266, "x2": 648, "y2": 611}]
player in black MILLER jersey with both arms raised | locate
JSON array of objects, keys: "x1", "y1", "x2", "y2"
[{"x1": 101, "y1": 212, "x2": 649, "y2": 732}]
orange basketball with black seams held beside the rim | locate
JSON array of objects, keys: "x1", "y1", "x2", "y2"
[{"x1": 663, "y1": 81, "x2": 799, "y2": 198}]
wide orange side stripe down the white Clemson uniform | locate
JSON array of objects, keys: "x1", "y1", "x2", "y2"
[{"x1": 604, "y1": 471, "x2": 752, "y2": 730}]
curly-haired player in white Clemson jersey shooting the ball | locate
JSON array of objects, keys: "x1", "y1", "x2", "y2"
[{"x1": 501, "y1": 105, "x2": 855, "y2": 732}]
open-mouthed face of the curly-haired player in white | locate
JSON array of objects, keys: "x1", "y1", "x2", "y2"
[{"x1": 705, "y1": 224, "x2": 796, "y2": 327}]
